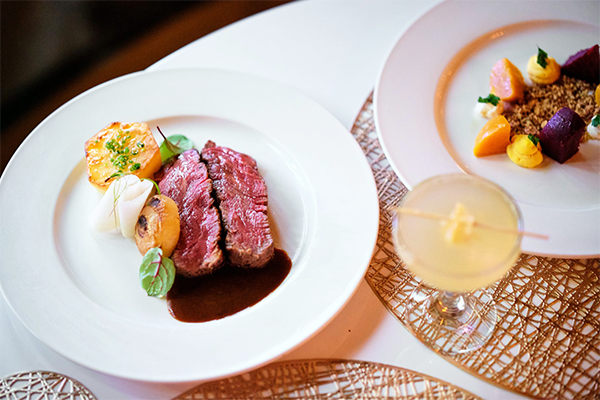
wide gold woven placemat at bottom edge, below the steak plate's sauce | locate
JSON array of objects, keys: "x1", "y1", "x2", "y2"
[{"x1": 175, "y1": 360, "x2": 479, "y2": 400}]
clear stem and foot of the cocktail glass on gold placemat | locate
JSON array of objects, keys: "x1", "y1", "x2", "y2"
[{"x1": 404, "y1": 284, "x2": 498, "y2": 355}]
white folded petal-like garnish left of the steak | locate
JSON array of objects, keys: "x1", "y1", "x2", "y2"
[{"x1": 89, "y1": 175, "x2": 154, "y2": 237}]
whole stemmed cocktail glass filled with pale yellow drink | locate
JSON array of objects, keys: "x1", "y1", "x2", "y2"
[{"x1": 393, "y1": 174, "x2": 523, "y2": 354}]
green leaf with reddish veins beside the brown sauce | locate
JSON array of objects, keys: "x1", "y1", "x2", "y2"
[{"x1": 140, "y1": 247, "x2": 175, "y2": 297}]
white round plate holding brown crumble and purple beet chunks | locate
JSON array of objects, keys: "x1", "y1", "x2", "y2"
[{"x1": 374, "y1": 1, "x2": 600, "y2": 258}]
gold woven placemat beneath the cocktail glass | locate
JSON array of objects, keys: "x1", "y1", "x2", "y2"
[{"x1": 352, "y1": 94, "x2": 600, "y2": 399}]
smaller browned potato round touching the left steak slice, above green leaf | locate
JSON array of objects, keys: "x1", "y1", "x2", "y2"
[{"x1": 135, "y1": 194, "x2": 180, "y2": 257}]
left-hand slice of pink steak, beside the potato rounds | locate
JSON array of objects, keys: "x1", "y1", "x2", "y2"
[{"x1": 156, "y1": 150, "x2": 223, "y2": 277}]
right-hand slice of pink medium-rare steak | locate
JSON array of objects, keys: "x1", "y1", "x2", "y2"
[{"x1": 202, "y1": 141, "x2": 275, "y2": 268}]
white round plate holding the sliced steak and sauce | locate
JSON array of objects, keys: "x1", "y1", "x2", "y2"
[{"x1": 0, "y1": 69, "x2": 379, "y2": 382}]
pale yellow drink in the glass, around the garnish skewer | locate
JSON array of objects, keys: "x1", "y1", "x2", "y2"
[{"x1": 394, "y1": 174, "x2": 521, "y2": 293}]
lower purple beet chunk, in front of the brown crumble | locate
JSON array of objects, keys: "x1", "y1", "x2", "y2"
[{"x1": 540, "y1": 107, "x2": 586, "y2": 164}]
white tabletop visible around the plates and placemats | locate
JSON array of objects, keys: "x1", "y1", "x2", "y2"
[{"x1": 0, "y1": 0, "x2": 523, "y2": 399}]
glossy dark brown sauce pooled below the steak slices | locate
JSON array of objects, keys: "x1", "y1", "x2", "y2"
[{"x1": 167, "y1": 249, "x2": 292, "y2": 322}]
